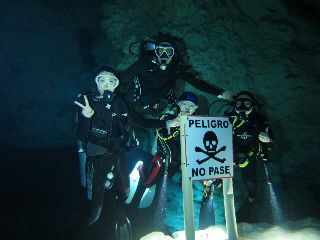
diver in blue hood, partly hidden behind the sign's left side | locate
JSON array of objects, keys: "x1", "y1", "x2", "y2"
[{"x1": 156, "y1": 92, "x2": 198, "y2": 177}]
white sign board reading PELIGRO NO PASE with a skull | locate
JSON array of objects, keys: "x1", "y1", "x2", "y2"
[{"x1": 185, "y1": 116, "x2": 233, "y2": 181}]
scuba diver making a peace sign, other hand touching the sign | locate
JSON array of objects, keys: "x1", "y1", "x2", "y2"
[{"x1": 74, "y1": 66, "x2": 179, "y2": 240}]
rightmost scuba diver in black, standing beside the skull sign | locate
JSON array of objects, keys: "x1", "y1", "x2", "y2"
[{"x1": 225, "y1": 91, "x2": 275, "y2": 203}]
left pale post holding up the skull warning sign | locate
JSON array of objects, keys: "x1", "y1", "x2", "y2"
[{"x1": 180, "y1": 116, "x2": 195, "y2": 240}]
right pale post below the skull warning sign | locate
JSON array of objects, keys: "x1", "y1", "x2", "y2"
[{"x1": 223, "y1": 178, "x2": 238, "y2": 240}]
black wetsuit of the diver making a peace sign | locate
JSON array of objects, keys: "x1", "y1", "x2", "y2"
[{"x1": 77, "y1": 92, "x2": 165, "y2": 214}]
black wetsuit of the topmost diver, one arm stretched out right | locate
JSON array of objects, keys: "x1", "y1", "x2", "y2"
[{"x1": 120, "y1": 57, "x2": 223, "y2": 108}]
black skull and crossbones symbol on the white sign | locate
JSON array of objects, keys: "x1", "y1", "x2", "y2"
[{"x1": 195, "y1": 131, "x2": 226, "y2": 165}]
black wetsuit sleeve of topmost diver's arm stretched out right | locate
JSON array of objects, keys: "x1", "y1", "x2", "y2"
[{"x1": 179, "y1": 68, "x2": 224, "y2": 96}]
